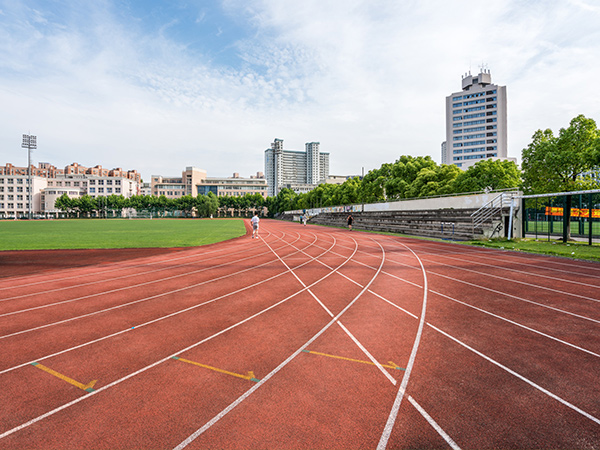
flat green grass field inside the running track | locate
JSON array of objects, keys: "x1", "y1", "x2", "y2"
[{"x1": 0, "y1": 219, "x2": 246, "y2": 250}]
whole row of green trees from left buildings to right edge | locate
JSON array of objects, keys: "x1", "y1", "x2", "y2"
[{"x1": 55, "y1": 115, "x2": 600, "y2": 222}]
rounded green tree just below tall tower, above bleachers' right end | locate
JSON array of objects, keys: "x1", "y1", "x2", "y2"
[{"x1": 452, "y1": 159, "x2": 521, "y2": 193}]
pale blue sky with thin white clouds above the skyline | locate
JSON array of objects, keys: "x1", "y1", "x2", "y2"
[{"x1": 0, "y1": 0, "x2": 600, "y2": 179}]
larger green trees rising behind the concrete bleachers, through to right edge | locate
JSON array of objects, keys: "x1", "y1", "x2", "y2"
[{"x1": 270, "y1": 115, "x2": 600, "y2": 212}]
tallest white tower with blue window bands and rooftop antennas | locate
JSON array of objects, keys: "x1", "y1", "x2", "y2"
[{"x1": 442, "y1": 69, "x2": 507, "y2": 169}]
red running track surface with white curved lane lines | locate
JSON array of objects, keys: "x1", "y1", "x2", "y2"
[{"x1": 0, "y1": 220, "x2": 600, "y2": 450}]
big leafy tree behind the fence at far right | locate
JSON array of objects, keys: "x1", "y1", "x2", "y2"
[{"x1": 522, "y1": 115, "x2": 600, "y2": 240}]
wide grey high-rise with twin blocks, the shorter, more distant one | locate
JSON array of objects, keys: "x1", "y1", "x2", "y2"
[{"x1": 265, "y1": 139, "x2": 329, "y2": 197}]
